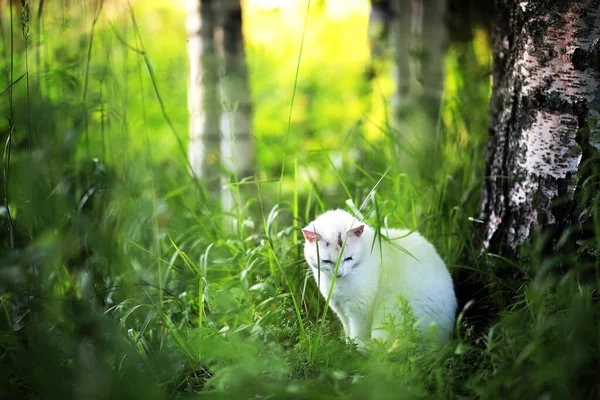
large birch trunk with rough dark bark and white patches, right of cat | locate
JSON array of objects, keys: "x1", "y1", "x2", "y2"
[{"x1": 481, "y1": 0, "x2": 600, "y2": 254}]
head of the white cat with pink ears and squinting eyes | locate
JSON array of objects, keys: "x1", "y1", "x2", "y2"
[{"x1": 302, "y1": 210, "x2": 365, "y2": 278}]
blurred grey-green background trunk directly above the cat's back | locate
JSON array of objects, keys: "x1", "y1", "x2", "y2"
[{"x1": 390, "y1": 0, "x2": 447, "y2": 173}]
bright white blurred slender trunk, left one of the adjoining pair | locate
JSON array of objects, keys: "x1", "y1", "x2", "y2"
[{"x1": 186, "y1": 0, "x2": 221, "y2": 192}]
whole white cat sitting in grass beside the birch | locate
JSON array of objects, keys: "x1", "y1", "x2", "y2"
[{"x1": 302, "y1": 210, "x2": 456, "y2": 347}]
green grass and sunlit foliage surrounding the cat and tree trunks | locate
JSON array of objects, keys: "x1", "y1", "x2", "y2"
[{"x1": 0, "y1": 2, "x2": 600, "y2": 399}]
